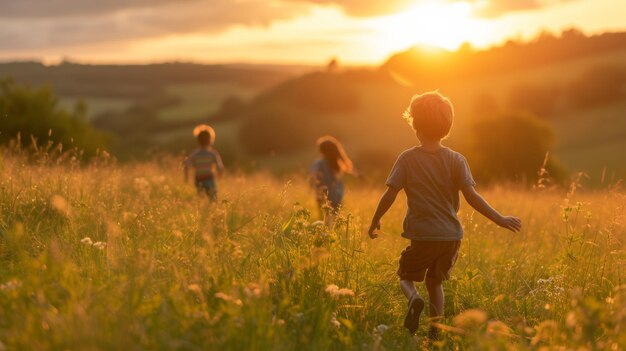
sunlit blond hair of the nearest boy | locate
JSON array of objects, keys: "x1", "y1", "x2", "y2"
[{"x1": 403, "y1": 91, "x2": 454, "y2": 139}]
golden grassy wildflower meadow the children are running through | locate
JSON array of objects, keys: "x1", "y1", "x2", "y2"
[{"x1": 0, "y1": 150, "x2": 626, "y2": 350}]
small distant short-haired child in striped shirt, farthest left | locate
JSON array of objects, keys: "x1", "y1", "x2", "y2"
[{"x1": 184, "y1": 124, "x2": 224, "y2": 202}]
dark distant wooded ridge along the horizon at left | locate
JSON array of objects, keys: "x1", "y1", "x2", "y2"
[{"x1": 0, "y1": 61, "x2": 291, "y2": 99}]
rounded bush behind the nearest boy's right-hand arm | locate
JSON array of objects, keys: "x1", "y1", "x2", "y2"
[{"x1": 468, "y1": 113, "x2": 566, "y2": 182}]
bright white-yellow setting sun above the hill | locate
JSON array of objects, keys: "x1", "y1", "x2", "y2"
[{"x1": 371, "y1": 1, "x2": 479, "y2": 51}]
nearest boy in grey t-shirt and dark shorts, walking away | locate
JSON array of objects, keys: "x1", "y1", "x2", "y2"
[{"x1": 368, "y1": 92, "x2": 521, "y2": 340}]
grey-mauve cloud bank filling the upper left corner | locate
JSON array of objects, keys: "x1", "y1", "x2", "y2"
[{"x1": 0, "y1": 0, "x2": 310, "y2": 50}]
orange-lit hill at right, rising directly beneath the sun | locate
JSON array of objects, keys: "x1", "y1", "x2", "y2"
[{"x1": 227, "y1": 30, "x2": 626, "y2": 180}]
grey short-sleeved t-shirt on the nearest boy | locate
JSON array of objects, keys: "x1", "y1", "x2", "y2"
[{"x1": 386, "y1": 147, "x2": 476, "y2": 241}]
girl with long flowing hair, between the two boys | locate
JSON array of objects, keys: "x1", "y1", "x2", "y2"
[{"x1": 311, "y1": 136, "x2": 354, "y2": 223}]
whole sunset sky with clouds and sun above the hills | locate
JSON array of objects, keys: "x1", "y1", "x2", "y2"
[{"x1": 0, "y1": 0, "x2": 626, "y2": 64}]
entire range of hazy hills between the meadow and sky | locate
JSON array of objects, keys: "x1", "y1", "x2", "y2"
[{"x1": 0, "y1": 30, "x2": 626, "y2": 183}]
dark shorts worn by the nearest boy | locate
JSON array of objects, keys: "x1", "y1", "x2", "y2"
[{"x1": 398, "y1": 240, "x2": 461, "y2": 282}]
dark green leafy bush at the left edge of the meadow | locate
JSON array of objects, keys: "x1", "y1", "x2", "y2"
[{"x1": 0, "y1": 78, "x2": 108, "y2": 158}]
